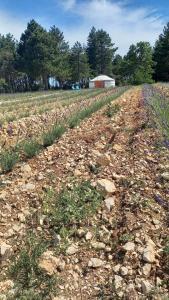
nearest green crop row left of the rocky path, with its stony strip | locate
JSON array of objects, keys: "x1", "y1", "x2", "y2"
[{"x1": 0, "y1": 88, "x2": 126, "y2": 172}]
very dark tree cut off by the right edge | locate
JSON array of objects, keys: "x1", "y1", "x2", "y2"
[{"x1": 153, "y1": 23, "x2": 169, "y2": 81}]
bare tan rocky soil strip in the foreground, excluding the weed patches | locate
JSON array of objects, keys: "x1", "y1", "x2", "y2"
[{"x1": 0, "y1": 88, "x2": 169, "y2": 300}]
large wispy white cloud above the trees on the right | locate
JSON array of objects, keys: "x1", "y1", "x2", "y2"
[{"x1": 60, "y1": 0, "x2": 164, "y2": 54}]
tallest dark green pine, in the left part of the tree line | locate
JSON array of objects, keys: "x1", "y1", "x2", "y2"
[{"x1": 17, "y1": 20, "x2": 51, "y2": 89}]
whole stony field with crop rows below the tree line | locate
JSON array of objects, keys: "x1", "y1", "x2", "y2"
[{"x1": 0, "y1": 83, "x2": 169, "y2": 300}]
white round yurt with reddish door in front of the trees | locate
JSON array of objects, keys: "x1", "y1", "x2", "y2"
[{"x1": 89, "y1": 75, "x2": 115, "y2": 89}]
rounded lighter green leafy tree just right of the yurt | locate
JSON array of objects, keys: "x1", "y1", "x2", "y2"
[{"x1": 122, "y1": 42, "x2": 154, "y2": 84}]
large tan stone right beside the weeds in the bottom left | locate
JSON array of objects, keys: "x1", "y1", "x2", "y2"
[{"x1": 39, "y1": 251, "x2": 65, "y2": 275}]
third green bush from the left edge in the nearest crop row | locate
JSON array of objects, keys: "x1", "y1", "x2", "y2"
[{"x1": 43, "y1": 125, "x2": 66, "y2": 147}]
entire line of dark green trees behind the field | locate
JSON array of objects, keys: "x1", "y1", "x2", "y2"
[{"x1": 0, "y1": 20, "x2": 169, "y2": 92}]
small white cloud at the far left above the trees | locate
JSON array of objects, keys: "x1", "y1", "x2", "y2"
[{"x1": 0, "y1": 10, "x2": 27, "y2": 39}]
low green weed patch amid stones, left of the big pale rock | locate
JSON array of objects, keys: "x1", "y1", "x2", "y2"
[{"x1": 44, "y1": 181, "x2": 103, "y2": 234}]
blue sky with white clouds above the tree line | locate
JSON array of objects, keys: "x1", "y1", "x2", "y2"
[{"x1": 0, "y1": 0, "x2": 169, "y2": 55}]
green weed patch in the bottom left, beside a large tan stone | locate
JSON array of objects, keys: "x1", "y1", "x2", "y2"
[{"x1": 9, "y1": 235, "x2": 56, "y2": 300}]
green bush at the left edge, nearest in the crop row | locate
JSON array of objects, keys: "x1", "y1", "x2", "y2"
[{"x1": 0, "y1": 150, "x2": 19, "y2": 173}]
